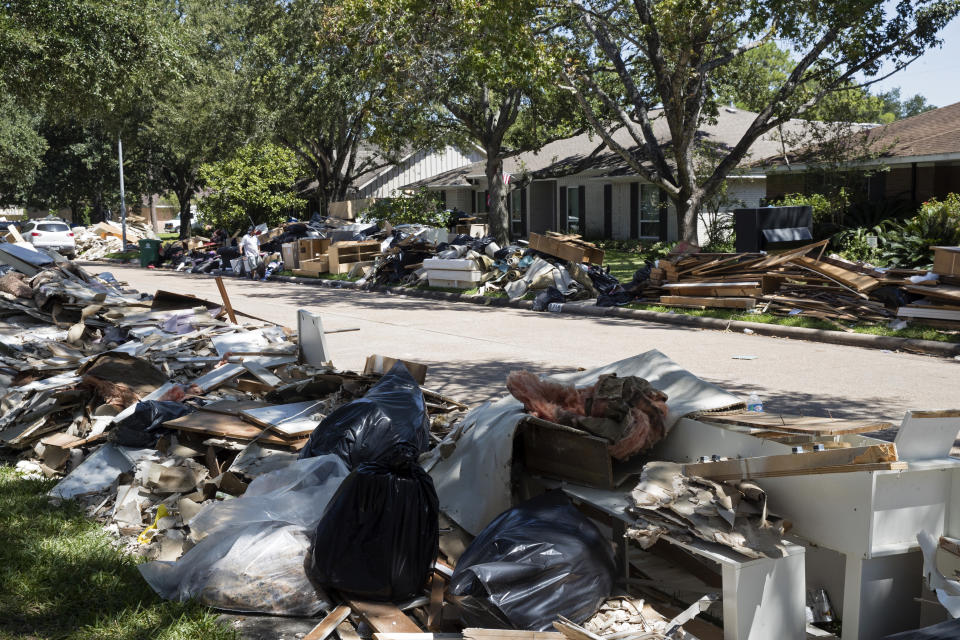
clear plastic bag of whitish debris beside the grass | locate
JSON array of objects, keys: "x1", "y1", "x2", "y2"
[{"x1": 139, "y1": 455, "x2": 348, "y2": 616}]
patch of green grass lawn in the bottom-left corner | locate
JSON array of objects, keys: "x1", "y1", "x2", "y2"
[{"x1": 0, "y1": 465, "x2": 237, "y2": 640}]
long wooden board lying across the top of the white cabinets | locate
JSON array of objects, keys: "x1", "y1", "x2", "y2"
[{"x1": 683, "y1": 443, "x2": 907, "y2": 481}]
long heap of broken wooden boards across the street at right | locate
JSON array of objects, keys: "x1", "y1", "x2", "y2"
[{"x1": 645, "y1": 240, "x2": 960, "y2": 331}]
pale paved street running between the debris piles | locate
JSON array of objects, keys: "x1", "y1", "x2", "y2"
[{"x1": 94, "y1": 263, "x2": 960, "y2": 424}]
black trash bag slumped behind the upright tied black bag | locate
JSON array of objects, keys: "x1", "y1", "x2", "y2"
[{"x1": 300, "y1": 362, "x2": 430, "y2": 469}]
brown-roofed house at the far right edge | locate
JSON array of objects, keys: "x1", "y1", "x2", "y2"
[{"x1": 766, "y1": 102, "x2": 960, "y2": 205}]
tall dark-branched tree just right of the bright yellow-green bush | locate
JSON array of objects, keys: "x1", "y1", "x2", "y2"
[{"x1": 244, "y1": 0, "x2": 428, "y2": 218}]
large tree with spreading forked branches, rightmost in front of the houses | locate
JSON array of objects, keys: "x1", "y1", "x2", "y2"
[{"x1": 565, "y1": 0, "x2": 960, "y2": 243}]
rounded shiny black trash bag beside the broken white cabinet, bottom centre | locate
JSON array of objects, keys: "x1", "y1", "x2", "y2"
[{"x1": 449, "y1": 490, "x2": 615, "y2": 631}]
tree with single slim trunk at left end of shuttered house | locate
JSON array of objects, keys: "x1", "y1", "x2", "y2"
[{"x1": 395, "y1": 0, "x2": 582, "y2": 243}]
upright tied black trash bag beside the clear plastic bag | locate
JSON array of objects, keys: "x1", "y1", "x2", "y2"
[{"x1": 308, "y1": 462, "x2": 440, "y2": 602}]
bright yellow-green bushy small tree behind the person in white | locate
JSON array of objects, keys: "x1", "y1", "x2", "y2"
[{"x1": 199, "y1": 144, "x2": 306, "y2": 229}]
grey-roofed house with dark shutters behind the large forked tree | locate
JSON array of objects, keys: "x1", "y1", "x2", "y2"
[{"x1": 404, "y1": 108, "x2": 804, "y2": 241}]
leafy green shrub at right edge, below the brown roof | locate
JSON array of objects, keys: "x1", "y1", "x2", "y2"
[{"x1": 882, "y1": 193, "x2": 960, "y2": 269}]
